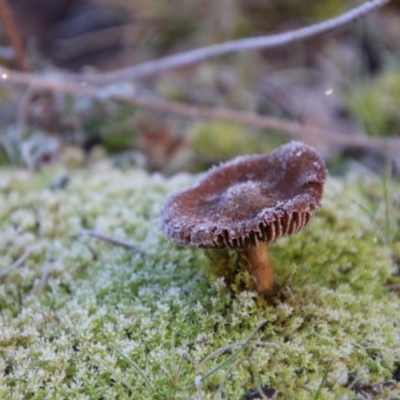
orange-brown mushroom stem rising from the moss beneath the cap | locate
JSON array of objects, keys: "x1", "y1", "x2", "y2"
[{"x1": 245, "y1": 243, "x2": 274, "y2": 297}]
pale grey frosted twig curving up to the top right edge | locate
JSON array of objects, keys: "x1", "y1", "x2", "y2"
[{"x1": 77, "y1": 0, "x2": 390, "y2": 85}]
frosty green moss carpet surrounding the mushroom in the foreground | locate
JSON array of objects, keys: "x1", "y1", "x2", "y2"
[{"x1": 0, "y1": 163, "x2": 400, "y2": 399}]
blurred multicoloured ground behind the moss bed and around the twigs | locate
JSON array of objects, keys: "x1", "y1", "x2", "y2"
[{"x1": 0, "y1": 0, "x2": 400, "y2": 175}]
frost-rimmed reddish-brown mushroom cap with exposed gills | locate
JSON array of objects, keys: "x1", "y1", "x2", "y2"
[{"x1": 160, "y1": 141, "x2": 326, "y2": 248}]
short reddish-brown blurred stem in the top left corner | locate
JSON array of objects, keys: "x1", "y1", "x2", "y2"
[{"x1": 0, "y1": 0, "x2": 30, "y2": 71}]
